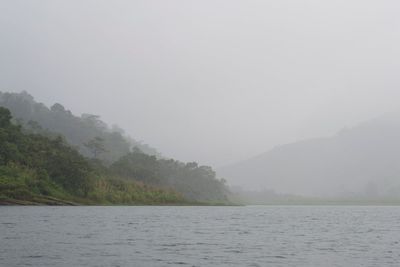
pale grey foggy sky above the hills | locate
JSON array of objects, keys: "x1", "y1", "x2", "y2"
[{"x1": 0, "y1": 0, "x2": 400, "y2": 166}]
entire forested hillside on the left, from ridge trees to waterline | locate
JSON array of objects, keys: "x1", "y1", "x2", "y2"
[{"x1": 0, "y1": 92, "x2": 229, "y2": 205}]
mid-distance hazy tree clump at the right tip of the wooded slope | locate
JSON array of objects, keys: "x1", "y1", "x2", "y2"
[{"x1": 110, "y1": 151, "x2": 228, "y2": 203}]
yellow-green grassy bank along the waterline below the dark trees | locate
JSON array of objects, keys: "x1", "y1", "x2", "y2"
[{"x1": 0, "y1": 164, "x2": 188, "y2": 205}]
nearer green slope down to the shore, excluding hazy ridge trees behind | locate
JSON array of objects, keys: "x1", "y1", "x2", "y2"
[{"x1": 0, "y1": 96, "x2": 229, "y2": 205}]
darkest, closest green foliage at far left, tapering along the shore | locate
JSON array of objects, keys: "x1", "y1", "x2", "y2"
[{"x1": 0, "y1": 107, "x2": 183, "y2": 204}]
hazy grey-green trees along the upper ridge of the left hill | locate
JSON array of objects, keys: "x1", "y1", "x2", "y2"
[{"x1": 0, "y1": 92, "x2": 159, "y2": 164}]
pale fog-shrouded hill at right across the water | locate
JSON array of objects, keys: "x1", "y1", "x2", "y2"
[{"x1": 217, "y1": 113, "x2": 400, "y2": 199}]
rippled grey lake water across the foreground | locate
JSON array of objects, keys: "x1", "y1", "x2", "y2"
[{"x1": 0, "y1": 206, "x2": 400, "y2": 267}]
